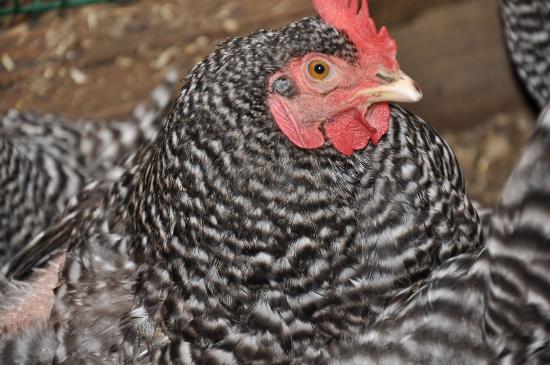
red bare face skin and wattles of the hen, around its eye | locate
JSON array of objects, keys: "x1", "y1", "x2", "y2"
[{"x1": 268, "y1": 52, "x2": 399, "y2": 156}]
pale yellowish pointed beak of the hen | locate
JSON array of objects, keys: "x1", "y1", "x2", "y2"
[{"x1": 355, "y1": 71, "x2": 423, "y2": 104}]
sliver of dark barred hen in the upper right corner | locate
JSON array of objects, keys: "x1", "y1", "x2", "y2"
[{"x1": 500, "y1": 0, "x2": 550, "y2": 108}]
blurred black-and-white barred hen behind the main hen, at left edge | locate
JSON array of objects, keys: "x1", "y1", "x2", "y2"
[{"x1": 0, "y1": 70, "x2": 178, "y2": 267}]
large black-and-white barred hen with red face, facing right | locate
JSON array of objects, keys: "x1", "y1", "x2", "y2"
[{"x1": 0, "y1": 0, "x2": 480, "y2": 364}]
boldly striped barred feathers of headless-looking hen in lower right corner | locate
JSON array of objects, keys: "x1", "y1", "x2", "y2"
[{"x1": 333, "y1": 100, "x2": 550, "y2": 364}]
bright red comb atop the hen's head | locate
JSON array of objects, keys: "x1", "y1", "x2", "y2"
[{"x1": 313, "y1": 0, "x2": 397, "y2": 66}]
